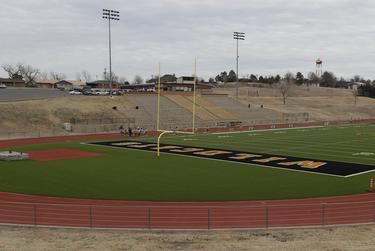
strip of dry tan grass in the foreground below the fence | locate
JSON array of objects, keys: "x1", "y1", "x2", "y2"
[{"x1": 0, "y1": 225, "x2": 375, "y2": 251}]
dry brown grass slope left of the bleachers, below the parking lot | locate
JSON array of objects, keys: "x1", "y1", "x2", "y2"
[{"x1": 0, "y1": 96, "x2": 133, "y2": 132}]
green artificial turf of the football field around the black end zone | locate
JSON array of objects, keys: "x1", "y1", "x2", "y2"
[{"x1": 0, "y1": 124, "x2": 375, "y2": 201}]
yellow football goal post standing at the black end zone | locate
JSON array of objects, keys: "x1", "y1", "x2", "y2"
[{"x1": 156, "y1": 59, "x2": 197, "y2": 156}]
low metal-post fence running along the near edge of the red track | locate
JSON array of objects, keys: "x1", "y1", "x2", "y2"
[{"x1": 0, "y1": 201, "x2": 375, "y2": 230}]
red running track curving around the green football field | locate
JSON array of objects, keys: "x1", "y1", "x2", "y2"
[{"x1": 0, "y1": 129, "x2": 375, "y2": 229}]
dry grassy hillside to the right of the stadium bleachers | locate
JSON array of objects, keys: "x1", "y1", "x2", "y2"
[{"x1": 219, "y1": 86, "x2": 375, "y2": 121}]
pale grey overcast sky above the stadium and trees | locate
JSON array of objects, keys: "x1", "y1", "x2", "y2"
[{"x1": 0, "y1": 0, "x2": 375, "y2": 81}]
